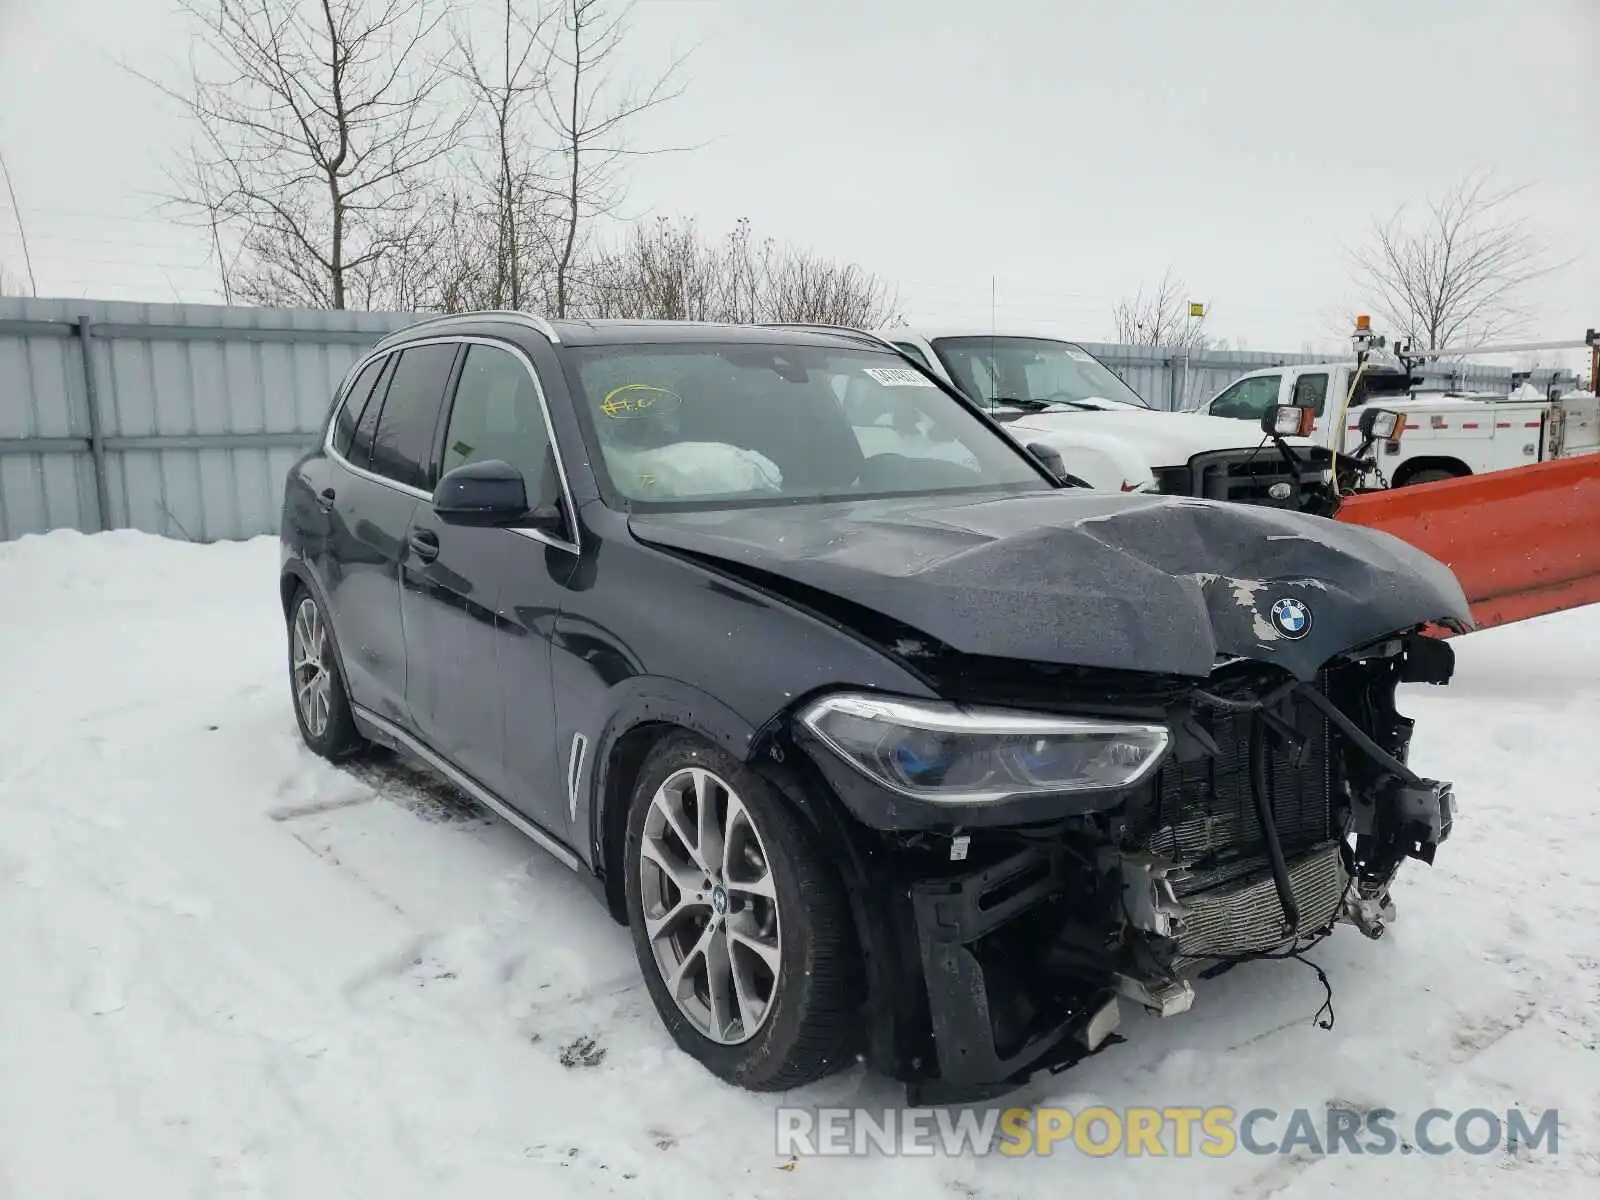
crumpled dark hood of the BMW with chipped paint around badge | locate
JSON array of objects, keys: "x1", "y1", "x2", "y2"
[{"x1": 629, "y1": 490, "x2": 1472, "y2": 678}]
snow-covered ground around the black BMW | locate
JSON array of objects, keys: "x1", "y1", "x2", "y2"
[{"x1": 0, "y1": 533, "x2": 1600, "y2": 1200}]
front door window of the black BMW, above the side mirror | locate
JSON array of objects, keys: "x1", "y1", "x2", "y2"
[{"x1": 440, "y1": 346, "x2": 560, "y2": 506}]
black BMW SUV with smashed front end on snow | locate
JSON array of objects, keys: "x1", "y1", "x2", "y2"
[{"x1": 282, "y1": 314, "x2": 1470, "y2": 1102}]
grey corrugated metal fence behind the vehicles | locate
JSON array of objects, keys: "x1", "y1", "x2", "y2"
[{"x1": 0, "y1": 296, "x2": 1561, "y2": 541}]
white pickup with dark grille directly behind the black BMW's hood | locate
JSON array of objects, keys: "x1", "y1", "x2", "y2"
[{"x1": 875, "y1": 326, "x2": 1336, "y2": 512}]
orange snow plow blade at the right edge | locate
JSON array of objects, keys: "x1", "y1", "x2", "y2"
[{"x1": 1338, "y1": 454, "x2": 1600, "y2": 627}]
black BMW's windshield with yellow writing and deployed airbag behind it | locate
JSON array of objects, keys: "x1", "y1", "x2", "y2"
[{"x1": 563, "y1": 342, "x2": 1053, "y2": 509}]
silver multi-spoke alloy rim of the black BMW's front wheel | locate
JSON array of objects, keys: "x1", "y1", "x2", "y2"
[{"x1": 638, "y1": 766, "x2": 782, "y2": 1045}]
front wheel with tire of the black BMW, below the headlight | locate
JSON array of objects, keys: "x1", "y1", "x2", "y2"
[{"x1": 622, "y1": 733, "x2": 861, "y2": 1091}]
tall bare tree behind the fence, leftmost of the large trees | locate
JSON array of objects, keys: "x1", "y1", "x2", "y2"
[{"x1": 146, "y1": 0, "x2": 464, "y2": 309}]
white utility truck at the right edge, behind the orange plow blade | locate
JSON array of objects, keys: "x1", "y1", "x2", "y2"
[{"x1": 1195, "y1": 340, "x2": 1600, "y2": 488}]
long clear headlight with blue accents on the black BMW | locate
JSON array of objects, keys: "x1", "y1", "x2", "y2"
[{"x1": 800, "y1": 694, "x2": 1171, "y2": 805}]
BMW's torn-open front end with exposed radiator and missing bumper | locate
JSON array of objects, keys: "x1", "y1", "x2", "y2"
[{"x1": 793, "y1": 634, "x2": 1454, "y2": 1102}]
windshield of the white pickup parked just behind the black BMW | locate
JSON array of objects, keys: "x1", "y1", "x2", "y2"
[{"x1": 933, "y1": 338, "x2": 1149, "y2": 410}]
